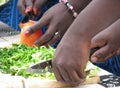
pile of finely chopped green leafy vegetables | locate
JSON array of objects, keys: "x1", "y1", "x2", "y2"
[{"x1": 0, "y1": 44, "x2": 55, "y2": 78}]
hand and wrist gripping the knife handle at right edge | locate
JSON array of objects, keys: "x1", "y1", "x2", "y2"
[{"x1": 91, "y1": 20, "x2": 120, "y2": 62}]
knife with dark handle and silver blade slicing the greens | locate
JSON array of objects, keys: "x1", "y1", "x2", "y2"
[{"x1": 26, "y1": 47, "x2": 99, "y2": 74}]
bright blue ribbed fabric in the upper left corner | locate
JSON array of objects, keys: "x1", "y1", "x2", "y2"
[{"x1": 0, "y1": 0, "x2": 22, "y2": 30}]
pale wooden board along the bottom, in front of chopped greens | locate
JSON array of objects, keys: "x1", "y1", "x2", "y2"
[{"x1": 0, "y1": 74, "x2": 100, "y2": 88}]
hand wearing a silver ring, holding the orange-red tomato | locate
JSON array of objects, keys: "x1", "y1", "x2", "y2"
[{"x1": 26, "y1": 3, "x2": 74, "y2": 46}]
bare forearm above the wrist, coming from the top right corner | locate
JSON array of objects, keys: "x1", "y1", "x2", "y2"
[{"x1": 67, "y1": 0, "x2": 120, "y2": 40}]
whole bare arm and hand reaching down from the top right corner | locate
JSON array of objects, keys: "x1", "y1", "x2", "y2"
[{"x1": 53, "y1": 0, "x2": 120, "y2": 83}]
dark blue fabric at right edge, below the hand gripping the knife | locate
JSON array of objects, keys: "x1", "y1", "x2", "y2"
[{"x1": 94, "y1": 55, "x2": 120, "y2": 76}]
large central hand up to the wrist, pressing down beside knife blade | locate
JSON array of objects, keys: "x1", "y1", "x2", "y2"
[{"x1": 52, "y1": 29, "x2": 90, "y2": 84}]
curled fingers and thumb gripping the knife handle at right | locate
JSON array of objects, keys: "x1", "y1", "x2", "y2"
[{"x1": 90, "y1": 31, "x2": 116, "y2": 62}]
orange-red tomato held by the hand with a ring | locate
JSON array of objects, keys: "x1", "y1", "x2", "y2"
[{"x1": 20, "y1": 21, "x2": 42, "y2": 46}]
